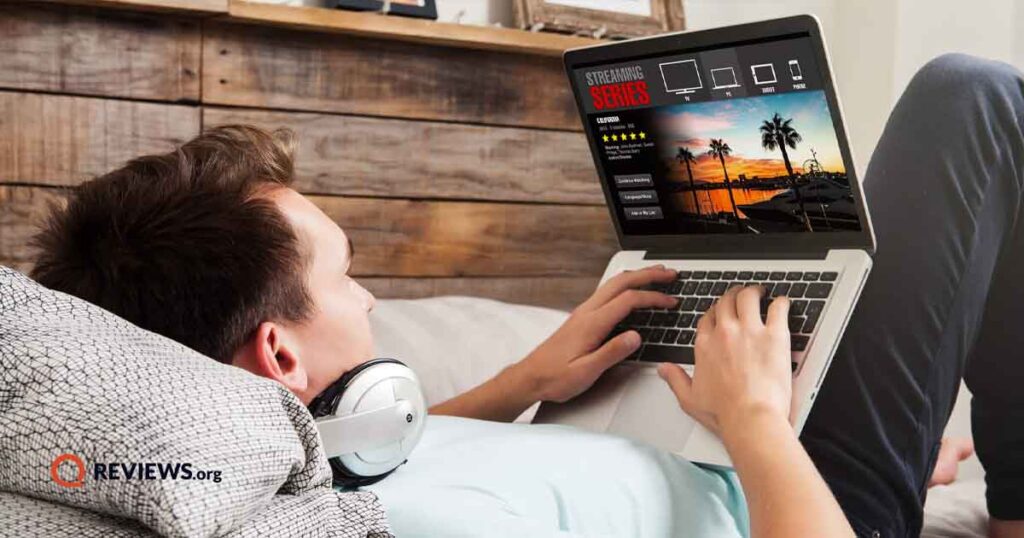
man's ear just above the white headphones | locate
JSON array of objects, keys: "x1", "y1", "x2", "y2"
[{"x1": 231, "y1": 322, "x2": 309, "y2": 396}]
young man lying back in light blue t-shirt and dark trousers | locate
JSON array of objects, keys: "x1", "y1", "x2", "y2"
[{"x1": 33, "y1": 56, "x2": 1024, "y2": 537}]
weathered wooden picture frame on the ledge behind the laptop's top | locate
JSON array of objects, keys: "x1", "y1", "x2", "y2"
[{"x1": 513, "y1": 0, "x2": 686, "y2": 38}]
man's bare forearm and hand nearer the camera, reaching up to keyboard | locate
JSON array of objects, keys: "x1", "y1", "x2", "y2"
[{"x1": 658, "y1": 286, "x2": 853, "y2": 538}]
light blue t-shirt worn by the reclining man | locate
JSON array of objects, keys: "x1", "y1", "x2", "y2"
[{"x1": 348, "y1": 416, "x2": 750, "y2": 538}]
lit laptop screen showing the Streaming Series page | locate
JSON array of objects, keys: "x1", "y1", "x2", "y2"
[{"x1": 573, "y1": 35, "x2": 860, "y2": 235}]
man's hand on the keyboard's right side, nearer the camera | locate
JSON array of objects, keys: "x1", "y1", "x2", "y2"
[{"x1": 657, "y1": 286, "x2": 793, "y2": 437}]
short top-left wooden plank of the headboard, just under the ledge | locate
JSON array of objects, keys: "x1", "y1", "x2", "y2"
[{"x1": 0, "y1": 2, "x2": 202, "y2": 101}]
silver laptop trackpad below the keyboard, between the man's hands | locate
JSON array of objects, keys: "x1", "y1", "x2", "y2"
[{"x1": 608, "y1": 368, "x2": 694, "y2": 453}]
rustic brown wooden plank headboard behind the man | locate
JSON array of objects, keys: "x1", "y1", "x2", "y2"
[{"x1": 0, "y1": 0, "x2": 614, "y2": 307}]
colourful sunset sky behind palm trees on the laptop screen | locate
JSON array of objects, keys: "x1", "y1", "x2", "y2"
[{"x1": 655, "y1": 91, "x2": 845, "y2": 181}]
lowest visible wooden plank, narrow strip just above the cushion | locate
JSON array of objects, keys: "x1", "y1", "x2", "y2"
[{"x1": 358, "y1": 277, "x2": 599, "y2": 311}]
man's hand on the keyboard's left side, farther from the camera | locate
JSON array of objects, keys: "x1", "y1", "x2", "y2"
[{"x1": 512, "y1": 265, "x2": 678, "y2": 402}]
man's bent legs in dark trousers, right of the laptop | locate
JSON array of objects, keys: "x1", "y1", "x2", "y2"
[{"x1": 802, "y1": 55, "x2": 1024, "y2": 536}]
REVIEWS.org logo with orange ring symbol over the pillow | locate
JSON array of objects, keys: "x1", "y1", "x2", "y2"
[{"x1": 50, "y1": 454, "x2": 220, "y2": 488}]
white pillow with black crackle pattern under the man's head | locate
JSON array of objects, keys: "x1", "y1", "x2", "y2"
[{"x1": 0, "y1": 266, "x2": 390, "y2": 536}]
